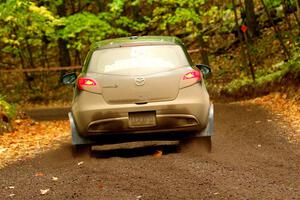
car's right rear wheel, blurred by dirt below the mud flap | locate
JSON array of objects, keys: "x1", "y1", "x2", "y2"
[{"x1": 180, "y1": 136, "x2": 212, "y2": 153}]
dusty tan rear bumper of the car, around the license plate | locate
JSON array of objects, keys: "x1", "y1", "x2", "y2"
[{"x1": 72, "y1": 85, "x2": 210, "y2": 136}]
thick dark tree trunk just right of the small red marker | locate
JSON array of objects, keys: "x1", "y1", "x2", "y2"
[{"x1": 245, "y1": 0, "x2": 259, "y2": 38}]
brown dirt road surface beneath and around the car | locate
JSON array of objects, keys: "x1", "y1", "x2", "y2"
[{"x1": 0, "y1": 104, "x2": 300, "y2": 200}]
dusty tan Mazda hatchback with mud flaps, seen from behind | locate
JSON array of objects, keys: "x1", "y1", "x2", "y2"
[{"x1": 62, "y1": 36, "x2": 213, "y2": 152}]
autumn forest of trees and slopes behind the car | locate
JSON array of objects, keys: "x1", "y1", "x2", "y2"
[{"x1": 0, "y1": 0, "x2": 300, "y2": 130}]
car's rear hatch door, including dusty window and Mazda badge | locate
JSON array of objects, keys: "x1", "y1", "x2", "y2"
[{"x1": 87, "y1": 45, "x2": 190, "y2": 104}]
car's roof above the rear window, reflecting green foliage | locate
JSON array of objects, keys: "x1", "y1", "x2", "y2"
[{"x1": 91, "y1": 36, "x2": 183, "y2": 50}]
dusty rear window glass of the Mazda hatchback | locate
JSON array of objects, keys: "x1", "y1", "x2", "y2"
[{"x1": 88, "y1": 45, "x2": 190, "y2": 75}]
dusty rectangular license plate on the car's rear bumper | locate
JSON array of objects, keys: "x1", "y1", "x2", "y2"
[{"x1": 129, "y1": 111, "x2": 156, "y2": 128}]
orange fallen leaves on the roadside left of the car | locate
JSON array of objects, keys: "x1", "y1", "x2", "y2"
[{"x1": 0, "y1": 119, "x2": 70, "y2": 169}]
